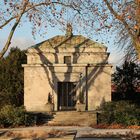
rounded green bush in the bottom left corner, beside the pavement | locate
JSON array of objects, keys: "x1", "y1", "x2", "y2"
[{"x1": 0, "y1": 105, "x2": 34, "y2": 127}]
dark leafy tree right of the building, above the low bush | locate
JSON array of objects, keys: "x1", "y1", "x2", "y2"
[{"x1": 112, "y1": 61, "x2": 140, "y2": 100}]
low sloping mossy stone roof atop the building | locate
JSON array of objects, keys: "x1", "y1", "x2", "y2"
[{"x1": 30, "y1": 35, "x2": 106, "y2": 49}]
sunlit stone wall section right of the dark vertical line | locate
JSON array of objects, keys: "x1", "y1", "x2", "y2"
[{"x1": 88, "y1": 65, "x2": 111, "y2": 110}]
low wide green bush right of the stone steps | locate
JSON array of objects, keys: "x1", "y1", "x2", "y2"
[{"x1": 98, "y1": 101, "x2": 140, "y2": 125}]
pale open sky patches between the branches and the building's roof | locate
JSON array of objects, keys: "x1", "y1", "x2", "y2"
[{"x1": 0, "y1": 13, "x2": 123, "y2": 68}]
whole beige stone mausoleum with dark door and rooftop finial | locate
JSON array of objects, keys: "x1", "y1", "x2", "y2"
[{"x1": 23, "y1": 25, "x2": 112, "y2": 112}]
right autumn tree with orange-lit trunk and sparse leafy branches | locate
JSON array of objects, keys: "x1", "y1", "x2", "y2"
[{"x1": 80, "y1": 0, "x2": 140, "y2": 59}]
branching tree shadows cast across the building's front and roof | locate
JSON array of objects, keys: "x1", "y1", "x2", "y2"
[{"x1": 35, "y1": 36, "x2": 108, "y2": 105}]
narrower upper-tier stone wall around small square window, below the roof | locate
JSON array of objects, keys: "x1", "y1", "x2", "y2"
[{"x1": 27, "y1": 47, "x2": 109, "y2": 64}]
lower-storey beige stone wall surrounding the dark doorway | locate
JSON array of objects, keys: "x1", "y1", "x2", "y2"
[{"x1": 24, "y1": 64, "x2": 111, "y2": 111}]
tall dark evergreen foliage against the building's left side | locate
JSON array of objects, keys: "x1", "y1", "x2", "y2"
[{"x1": 0, "y1": 48, "x2": 26, "y2": 106}]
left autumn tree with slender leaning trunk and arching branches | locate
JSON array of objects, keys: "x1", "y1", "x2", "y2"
[{"x1": 0, "y1": 0, "x2": 79, "y2": 58}]
